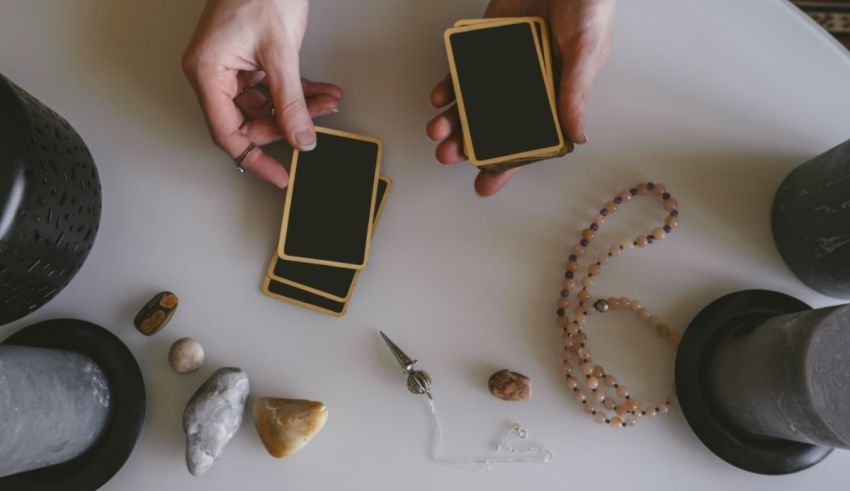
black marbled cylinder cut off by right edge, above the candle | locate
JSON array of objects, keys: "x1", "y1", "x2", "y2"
[{"x1": 771, "y1": 140, "x2": 850, "y2": 298}]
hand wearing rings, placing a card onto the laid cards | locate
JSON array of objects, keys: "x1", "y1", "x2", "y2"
[{"x1": 183, "y1": 0, "x2": 342, "y2": 188}]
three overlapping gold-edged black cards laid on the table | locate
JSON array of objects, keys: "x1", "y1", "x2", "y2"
[{"x1": 262, "y1": 127, "x2": 392, "y2": 317}]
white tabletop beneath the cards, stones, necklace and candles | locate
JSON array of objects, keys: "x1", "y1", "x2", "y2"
[{"x1": 0, "y1": 0, "x2": 850, "y2": 491}]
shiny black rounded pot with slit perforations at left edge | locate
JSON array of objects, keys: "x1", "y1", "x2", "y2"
[{"x1": 0, "y1": 75, "x2": 101, "y2": 324}]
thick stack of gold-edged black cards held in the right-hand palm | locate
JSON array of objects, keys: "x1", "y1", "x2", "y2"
[{"x1": 444, "y1": 17, "x2": 572, "y2": 172}]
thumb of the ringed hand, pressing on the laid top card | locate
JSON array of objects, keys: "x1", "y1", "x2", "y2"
[{"x1": 260, "y1": 49, "x2": 316, "y2": 151}]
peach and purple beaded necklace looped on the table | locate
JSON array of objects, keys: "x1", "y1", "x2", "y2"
[{"x1": 556, "y1": 182, "x2": 681, "y2": 428}]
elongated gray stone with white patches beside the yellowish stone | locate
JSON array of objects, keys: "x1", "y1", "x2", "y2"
[{"x1": 183, "y1": 367, "x2": 250, "y2": 476}]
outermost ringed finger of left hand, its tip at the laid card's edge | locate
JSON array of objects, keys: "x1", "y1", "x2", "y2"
[{"x1": 190, "y1": 67, "x2": 288, "y2": 188}]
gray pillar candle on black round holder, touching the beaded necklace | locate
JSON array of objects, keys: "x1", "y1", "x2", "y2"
[{"x1": 676, "y1": 290, "x2": 850, "y2": 474}]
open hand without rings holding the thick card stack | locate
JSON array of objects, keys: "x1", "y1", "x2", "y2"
[{"x1": 426, "y1": 0, "x2": 614, "y2": 196}]
